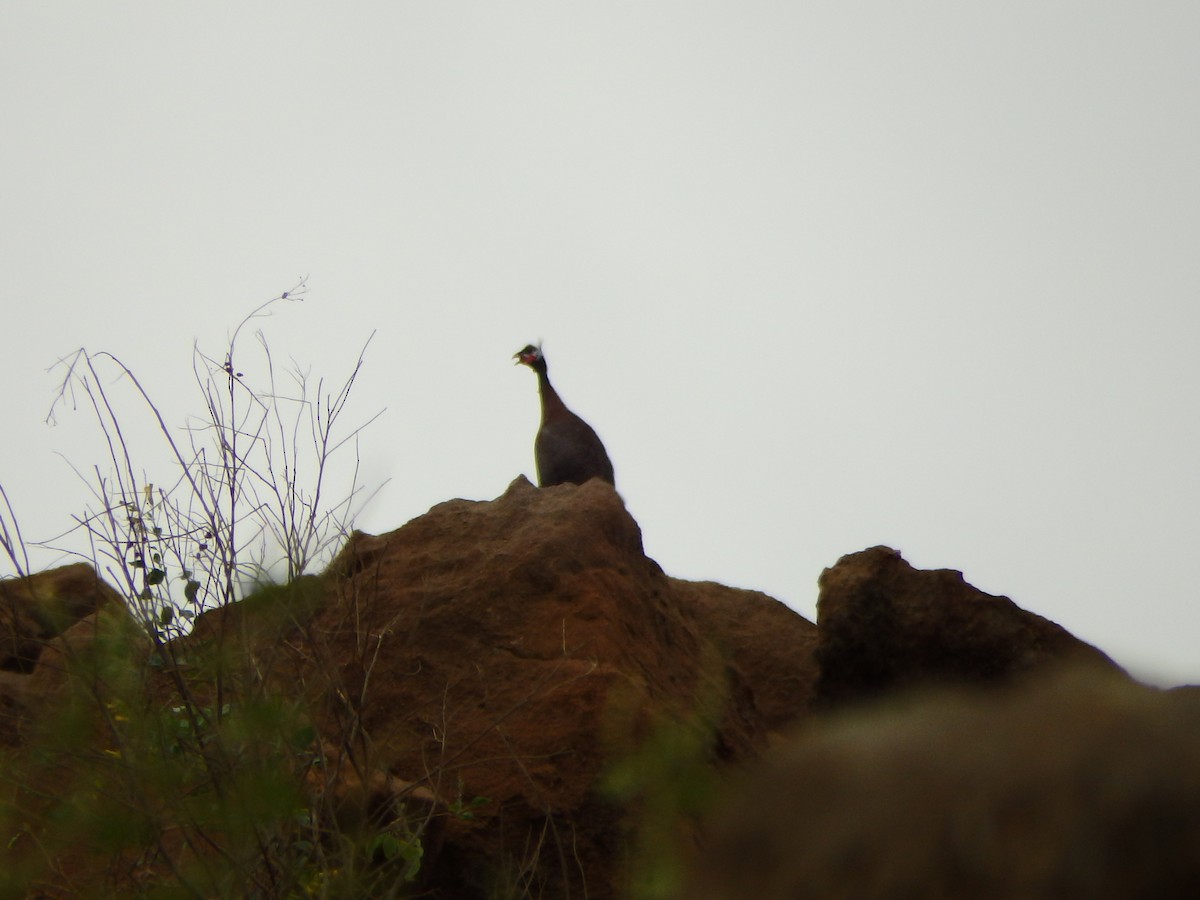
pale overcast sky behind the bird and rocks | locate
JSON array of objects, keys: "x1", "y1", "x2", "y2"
[{"x1": 0, "y1": 0, "x2": 1200, "y2": 683}]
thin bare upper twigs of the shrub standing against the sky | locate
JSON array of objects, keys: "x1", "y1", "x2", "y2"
[{"x1": 48, "y1": 281, "x2": 379, "y2": 637}]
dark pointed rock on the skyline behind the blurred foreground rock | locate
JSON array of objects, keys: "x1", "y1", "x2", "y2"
[{"x1": 816, "y1": 547, "x2": 1121, "y2": 707}]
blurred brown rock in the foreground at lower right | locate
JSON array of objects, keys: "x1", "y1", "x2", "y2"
[{"x1": 686, "y1": 666, "x2": 1200, "y2": 900}]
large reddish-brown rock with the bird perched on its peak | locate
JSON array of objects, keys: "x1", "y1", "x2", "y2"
[{"x1": 191, "y1": 478, "x2": 815, "y2": 900}]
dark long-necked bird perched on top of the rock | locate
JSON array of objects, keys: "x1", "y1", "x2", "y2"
[{"x1": 512, "y1": 343, "x2": 616, "y2": 487}]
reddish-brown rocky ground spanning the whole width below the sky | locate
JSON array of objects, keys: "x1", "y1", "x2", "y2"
[{"x1": 0, "y1": 478, "x2": 1200, "y2": 900}]
